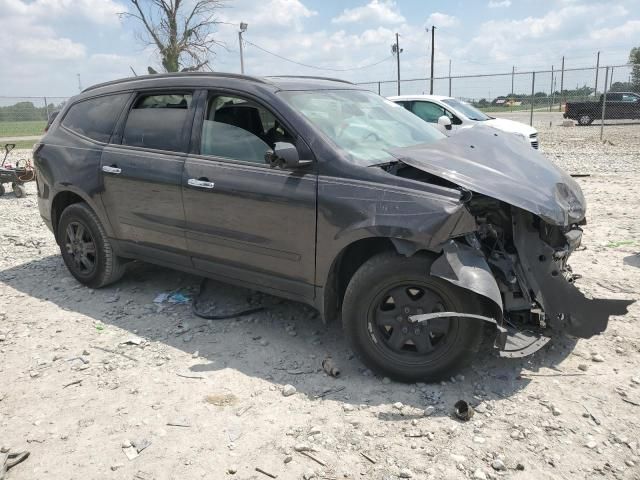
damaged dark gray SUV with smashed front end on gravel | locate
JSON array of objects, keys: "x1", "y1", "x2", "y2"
[{"x1": 34, "y1": 73, "x2": 630, "y2": 381}]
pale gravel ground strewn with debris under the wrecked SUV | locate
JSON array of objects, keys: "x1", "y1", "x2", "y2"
[{"x1": 0, "y1": 126, "x2": 640, "y2": 480}]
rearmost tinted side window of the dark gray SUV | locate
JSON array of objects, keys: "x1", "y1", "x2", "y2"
[{"x1": 62, "y1": 94, "x2": 129, "y2": 143}]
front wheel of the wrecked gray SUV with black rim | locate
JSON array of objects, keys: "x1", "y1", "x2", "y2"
[{"x1": 342, "y1": 253, "x2": 483, "y2": 382}]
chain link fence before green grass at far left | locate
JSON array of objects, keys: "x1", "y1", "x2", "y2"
[{"x1": 0, "y1": 97, "x2": 67, "y2": 148}]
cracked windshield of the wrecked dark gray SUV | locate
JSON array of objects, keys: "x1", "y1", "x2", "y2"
[{"x1": 280, "y1": 90, "x2": 445, "y2": 166}]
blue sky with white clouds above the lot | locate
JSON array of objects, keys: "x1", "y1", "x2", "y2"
[{"x1": 0, "y1": 0, "x2": 640, "y2": 97}]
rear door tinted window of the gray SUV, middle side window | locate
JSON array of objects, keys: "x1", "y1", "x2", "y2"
[{"x1": 122, "y1": 93, "x2": 192, "y2": 152}]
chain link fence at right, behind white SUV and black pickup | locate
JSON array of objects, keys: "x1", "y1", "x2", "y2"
[{"x1": 360, "y1": 64, "x2": 640, "y2": 141}]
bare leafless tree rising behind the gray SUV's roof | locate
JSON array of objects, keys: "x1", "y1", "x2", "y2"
[{"x1": 120, "y1": 0, "x2": 225, "y2": 73}]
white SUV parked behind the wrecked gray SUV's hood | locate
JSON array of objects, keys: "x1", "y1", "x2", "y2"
[{"x1": 389, "y1": 95, "x2": 538, "y2": 148}]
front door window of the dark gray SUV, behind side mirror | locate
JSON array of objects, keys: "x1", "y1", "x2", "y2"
[{"x1": 200, "y1": 96, "x2": 294, "y2": 164}]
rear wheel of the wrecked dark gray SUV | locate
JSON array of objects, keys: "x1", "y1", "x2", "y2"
[{"x1": 57, "y1": 203, "x2": 125, "y2": 288}]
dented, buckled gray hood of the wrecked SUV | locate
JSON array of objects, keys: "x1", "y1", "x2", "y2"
[{"x1": 390, "y1": 126, "x2": 586, "y2": 225}]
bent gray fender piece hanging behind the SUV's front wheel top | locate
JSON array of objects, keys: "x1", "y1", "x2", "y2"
[{"x1": 430, "y1": 240, "x2": 502, "y2": 320}]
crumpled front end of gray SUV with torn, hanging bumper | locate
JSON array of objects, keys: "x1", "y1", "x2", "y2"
[{"x1": 421, "y1": 195, "x2": 633, "y2": 357}]
